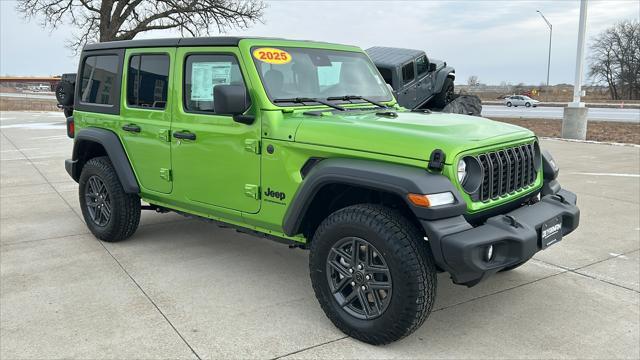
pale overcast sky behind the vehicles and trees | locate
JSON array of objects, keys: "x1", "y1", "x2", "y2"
[{"x1": 0, "y1": 0, "x2": 640, "y2": 85}]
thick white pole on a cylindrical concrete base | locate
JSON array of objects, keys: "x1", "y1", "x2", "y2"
[{"x1": 562, "y1": 0, "x2": 589, "y2": 140}]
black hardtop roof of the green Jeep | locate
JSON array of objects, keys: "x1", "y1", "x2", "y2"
[{"x1": 83, "y1": 36, "x2": 285, "y2": 51}]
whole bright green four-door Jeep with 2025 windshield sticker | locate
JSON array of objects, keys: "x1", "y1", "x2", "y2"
[{"x1": 64, "y1": 37, "x2": 579, "y2": 344}]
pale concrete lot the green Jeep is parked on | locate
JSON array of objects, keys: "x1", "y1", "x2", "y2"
[{"x1": 0, "y1": 112, "x2": 640, "y2": 359}]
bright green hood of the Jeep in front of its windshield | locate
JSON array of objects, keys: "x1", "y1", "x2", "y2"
[{"x1": 295, "y1": 111, "x2": 534, "y2": 163}]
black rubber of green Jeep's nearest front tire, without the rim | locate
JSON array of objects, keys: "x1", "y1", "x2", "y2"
[{"x1": 309, "y1": 204, "x2": 437, "y2": 345}]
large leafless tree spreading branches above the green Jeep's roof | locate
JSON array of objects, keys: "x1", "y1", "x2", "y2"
[{"x1": 16, "y1": 0, "x2": 265, "y2": 52}]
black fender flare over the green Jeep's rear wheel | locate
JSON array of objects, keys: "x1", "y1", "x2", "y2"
[{"x1": 68, "y1": 128, "x2": 140, "y2": 194}]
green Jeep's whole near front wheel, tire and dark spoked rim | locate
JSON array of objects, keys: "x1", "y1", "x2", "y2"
[{"x1": 309, "y1": 204, "x2": 437, "y2": 345}]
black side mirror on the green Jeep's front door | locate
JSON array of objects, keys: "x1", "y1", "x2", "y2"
[{"x1": 213, "y1": 84, "x2": 255, "y2": 125}]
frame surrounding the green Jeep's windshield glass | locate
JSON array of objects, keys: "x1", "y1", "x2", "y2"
[{"x1": 249, "y1": 45, "x2": 395, "y2": 108}]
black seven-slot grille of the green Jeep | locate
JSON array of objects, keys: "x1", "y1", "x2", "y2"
[{"x1": 476, "y1": 143, "x2": 537, "y2": 202}]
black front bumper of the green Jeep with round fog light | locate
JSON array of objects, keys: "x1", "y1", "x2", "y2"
[{"x1": 421, "y1": 190, "x2": 580, "y2": 286}]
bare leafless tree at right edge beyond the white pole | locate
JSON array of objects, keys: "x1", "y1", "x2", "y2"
[{"x1": 589, "y1": 21, "x2": 640, "y2": 100}]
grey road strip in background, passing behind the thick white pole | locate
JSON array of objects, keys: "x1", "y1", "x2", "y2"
[{"x1": 482, "y1": 105, "x2": 640, "y2": 123}]
